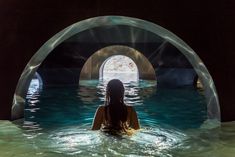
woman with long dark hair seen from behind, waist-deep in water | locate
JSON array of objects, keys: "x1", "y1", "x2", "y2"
[{"x1": 92, "y1": 79, "x2": 140, "y2": 134}]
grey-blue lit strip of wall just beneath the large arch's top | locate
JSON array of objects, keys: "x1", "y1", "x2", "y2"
[{"x1": 65, "y1": 25, "x2": 163, "y2": 43}]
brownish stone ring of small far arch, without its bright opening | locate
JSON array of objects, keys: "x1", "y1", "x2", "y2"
[{"x1": 80, "y1": 45, "x2": 156, "y2": 83}]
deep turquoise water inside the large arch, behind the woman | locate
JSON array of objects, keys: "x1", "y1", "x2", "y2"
[{"x1": 25, "y1": 81, "x2": 207, "y2": 129}]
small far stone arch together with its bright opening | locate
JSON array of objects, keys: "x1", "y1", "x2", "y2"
[{"x1": 79, "y1": 45, "x2": 156, "y2": 84}]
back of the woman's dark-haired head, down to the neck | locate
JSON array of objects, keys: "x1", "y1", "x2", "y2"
[{"x1": 106, "y1": 79, "x2": 124, "y2": 103}]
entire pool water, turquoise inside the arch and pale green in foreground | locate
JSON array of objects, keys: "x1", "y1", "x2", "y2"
[{"x1": 0, "y1": 81, "x2": 235, "y2": 157}]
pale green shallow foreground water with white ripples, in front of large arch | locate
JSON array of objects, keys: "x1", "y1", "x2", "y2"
[{"x1": 0, "y1": 121, "x2": 235, "y2": 157}]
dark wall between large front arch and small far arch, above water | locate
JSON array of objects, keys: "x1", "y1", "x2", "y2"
[{"x1": 38, "y1": 25, "x2": 194, "y2": 87}]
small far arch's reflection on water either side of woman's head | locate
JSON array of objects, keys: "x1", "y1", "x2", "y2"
[{"x1": 80, "y1": 80, "x2": 156, "y2": 106}]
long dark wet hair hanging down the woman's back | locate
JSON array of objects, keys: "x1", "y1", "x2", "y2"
[{"x1": 105, "y1": 79, "x2": 127, "y2": 130}]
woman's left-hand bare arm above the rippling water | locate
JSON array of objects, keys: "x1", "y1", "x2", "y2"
[{"x1": 91, "y1": 106, "x2": 104, "y2": 130}]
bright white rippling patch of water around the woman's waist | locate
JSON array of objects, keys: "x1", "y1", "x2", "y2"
[{"x1": 45, "y1": 124, "x2": 186, "y2": 156}]
